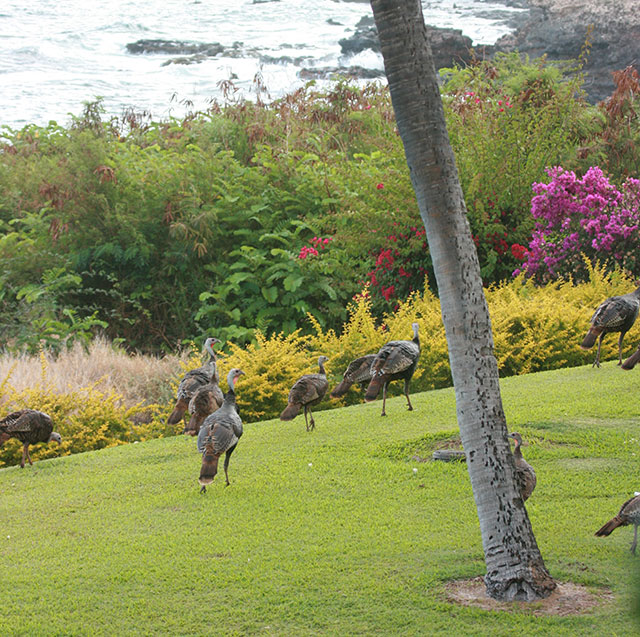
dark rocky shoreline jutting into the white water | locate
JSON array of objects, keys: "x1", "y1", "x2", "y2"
[{"x1": 127, "y1": 0, "x2": 640, "y2": 103}]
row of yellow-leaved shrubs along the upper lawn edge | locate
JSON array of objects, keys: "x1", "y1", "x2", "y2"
[{"x1": 0, "y1": 268, "x2": 640, "y2": 467}]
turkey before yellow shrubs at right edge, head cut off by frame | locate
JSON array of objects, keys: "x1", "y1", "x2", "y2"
[{"x1": 581, "y1": 287, "x2": 640, "y2": 367}]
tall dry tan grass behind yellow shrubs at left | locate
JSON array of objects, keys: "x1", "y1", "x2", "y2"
[{"x1": 0, "y1": 338, "x2": 191, "y2": 406}]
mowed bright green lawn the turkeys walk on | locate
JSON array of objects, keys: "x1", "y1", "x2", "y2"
[{"x1": 0, "y1": 363, "x2": 640, "y2": 635}]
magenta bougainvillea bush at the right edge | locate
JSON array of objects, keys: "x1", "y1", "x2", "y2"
[{"x1": 514, "y1": 166, "x2": 640, "y2": 283}]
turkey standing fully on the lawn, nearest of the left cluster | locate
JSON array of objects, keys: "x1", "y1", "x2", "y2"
[{"x1": 198, "y1": 367, "x2": 244, "y2": 493}]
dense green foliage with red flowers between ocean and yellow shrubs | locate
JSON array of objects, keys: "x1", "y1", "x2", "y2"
[{"x1": 0, "y1": 55, "x2": 638, "y2": 351}]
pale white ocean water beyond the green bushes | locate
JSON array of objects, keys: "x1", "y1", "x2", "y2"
[{"x1": 0, "y1": 0, "x2": 518, "y2": 129}]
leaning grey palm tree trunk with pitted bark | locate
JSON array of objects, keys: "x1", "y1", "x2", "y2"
[{"x1": 371, "y1": 0, "x2": 556, "y2": 601}]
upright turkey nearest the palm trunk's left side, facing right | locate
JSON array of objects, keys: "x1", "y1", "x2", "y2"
[{"x1": 364, "y1": 323, "x2": 420, "y2": 416}]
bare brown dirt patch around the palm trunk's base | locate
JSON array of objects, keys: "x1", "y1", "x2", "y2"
[{"x1": 445, "y1": 577, "x2": 613, "y2": 616}]
